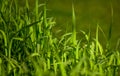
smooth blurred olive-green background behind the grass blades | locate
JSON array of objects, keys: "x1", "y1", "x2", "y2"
[{"x1": 20, "y1": 0, "x2": 120, "y2": 46}]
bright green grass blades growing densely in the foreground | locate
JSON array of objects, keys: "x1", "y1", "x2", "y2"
[{"x1": 0, "y1": 0, "x2": 120, "y2": 76}]
